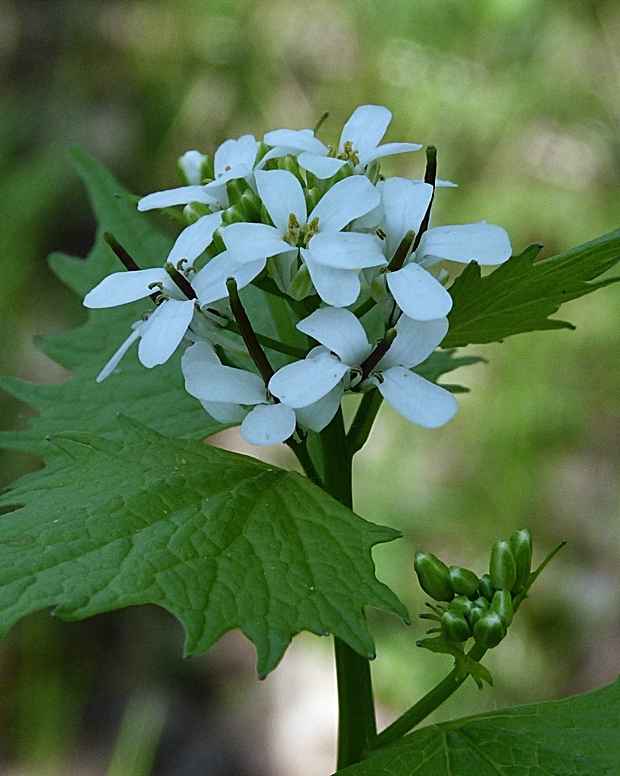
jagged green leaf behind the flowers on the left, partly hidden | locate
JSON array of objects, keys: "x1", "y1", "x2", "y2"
[{"x1": 0, "y1": 150, "x2": 224, "y2": 458}]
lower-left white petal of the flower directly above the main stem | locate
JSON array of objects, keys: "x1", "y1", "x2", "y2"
[{"x1": 269, "y1": 353, "x2": 349, "y2": 408}]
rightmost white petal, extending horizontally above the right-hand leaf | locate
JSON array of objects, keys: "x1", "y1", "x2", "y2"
[{"x1": 416, "y1": 221, "x2": 512, "y2": 267}]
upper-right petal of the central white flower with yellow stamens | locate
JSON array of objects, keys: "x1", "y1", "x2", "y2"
[{"x1": 308, "y1": 175, "x2": 381, "y2": 232}]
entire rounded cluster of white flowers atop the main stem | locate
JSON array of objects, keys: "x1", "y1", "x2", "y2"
[{"x1": 84, "y1": 105, "x2": 511, "y2": 445}]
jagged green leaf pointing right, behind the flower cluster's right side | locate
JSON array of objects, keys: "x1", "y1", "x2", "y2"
[{"x1": 442, "y1": 229, "x2": 620, "y2": 348}]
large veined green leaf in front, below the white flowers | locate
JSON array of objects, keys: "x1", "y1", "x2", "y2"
[{"x1": 0, "y1": 418, "x2": 407, "y2": 675}]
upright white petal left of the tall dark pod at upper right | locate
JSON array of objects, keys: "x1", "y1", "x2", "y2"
[{"x1": 382, "y1": 178, "x2": 433, "y2": 259}]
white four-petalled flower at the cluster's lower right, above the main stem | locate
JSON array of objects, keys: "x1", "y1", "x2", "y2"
[{"x1": 269, "y1": 307, "x2": 458, "y2": 428}]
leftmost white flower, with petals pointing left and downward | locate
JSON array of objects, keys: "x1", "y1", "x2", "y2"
[{"x1": 84, "y1": 268, "x2": 195, "y2": 382}]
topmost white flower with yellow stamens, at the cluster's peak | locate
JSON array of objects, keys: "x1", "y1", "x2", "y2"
[{"x1": 265, "y1": 105, "x2": 422, "y2": 179}]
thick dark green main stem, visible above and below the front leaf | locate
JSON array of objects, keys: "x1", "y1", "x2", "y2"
[{"x1": 321, "y1": 409, "x2": 377, "y2": 769}]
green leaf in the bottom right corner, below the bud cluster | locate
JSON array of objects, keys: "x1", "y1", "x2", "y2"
[{"x1": 338, "y1": 680, "x2": 620, "y2": 776}]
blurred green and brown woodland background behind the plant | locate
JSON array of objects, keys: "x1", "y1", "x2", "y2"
[{"x1": 0, "y1": 0, "x2": 620, "y2": 776}]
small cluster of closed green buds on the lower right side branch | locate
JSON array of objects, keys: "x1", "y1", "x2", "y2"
[{"x1": 414, "y1": 528, "x2": 533, "y2": 649}]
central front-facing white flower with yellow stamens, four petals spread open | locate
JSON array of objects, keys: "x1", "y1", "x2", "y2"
[{"x1": 211, "y1": 170, "x2": 386, "y2": 307}]
